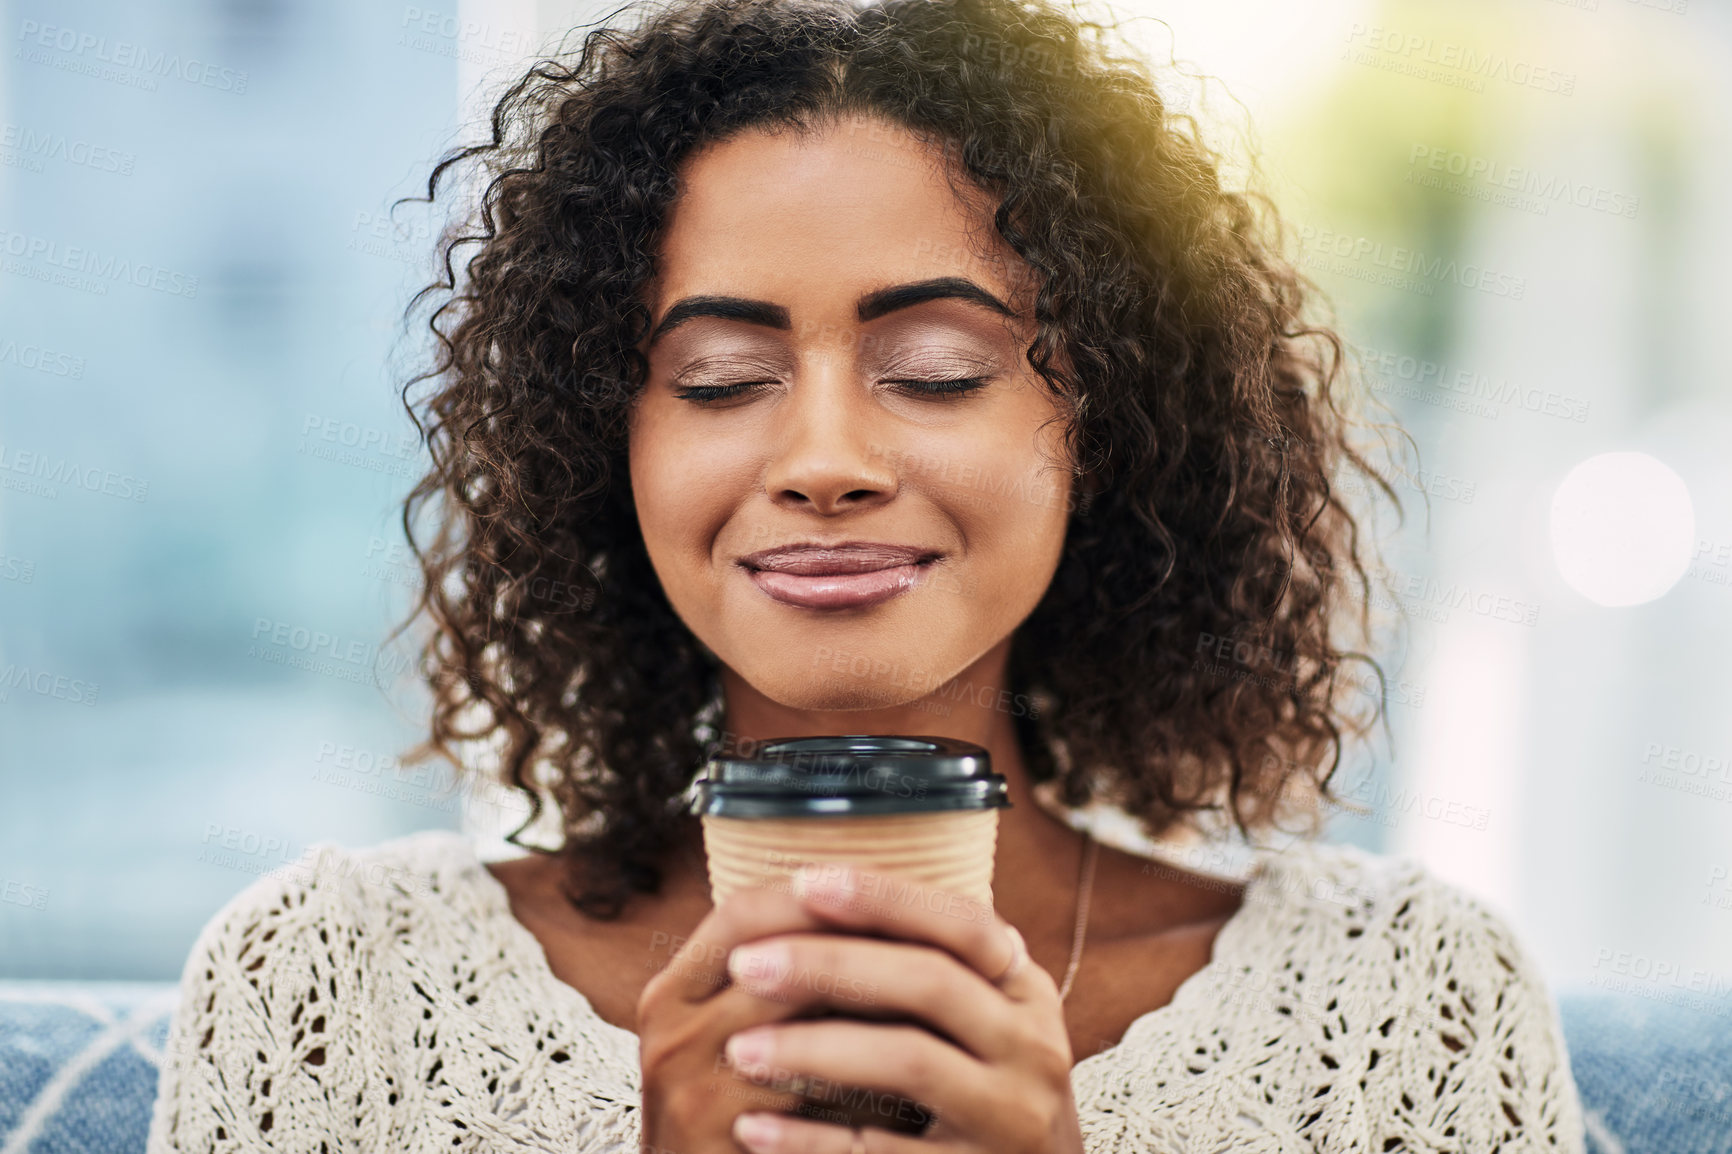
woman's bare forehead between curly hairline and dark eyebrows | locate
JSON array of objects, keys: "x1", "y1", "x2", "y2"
[{"x1": 650, "y1": 118, "x2": 1027, "y2": 315}]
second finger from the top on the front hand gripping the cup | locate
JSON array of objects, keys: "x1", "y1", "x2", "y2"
[{"x1": 729, "y1": 932, "x2": 1024, "y2": 1060}]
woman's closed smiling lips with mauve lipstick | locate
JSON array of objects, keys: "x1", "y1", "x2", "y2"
[{"x1": 740, "y1": 541, "x2": 942, "y2": 610}]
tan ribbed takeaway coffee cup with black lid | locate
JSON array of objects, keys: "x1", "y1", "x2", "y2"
[{"x1": 691, "y1": 735, "x2": 1010, "y2": 1133}]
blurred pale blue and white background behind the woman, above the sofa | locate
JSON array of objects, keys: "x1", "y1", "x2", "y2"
[{"x1": 0, "y1": 0, "x2": 1732, "y2": 1014}]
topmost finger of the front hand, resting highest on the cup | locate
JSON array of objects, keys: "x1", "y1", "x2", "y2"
[{"x1": 793, "y1": 861, "x2": 1057, "y2": 1002}]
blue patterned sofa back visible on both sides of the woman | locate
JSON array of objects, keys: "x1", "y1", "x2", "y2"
[{"x1": 0, "y1": 982, "x2": 1732, "y2": 1154}]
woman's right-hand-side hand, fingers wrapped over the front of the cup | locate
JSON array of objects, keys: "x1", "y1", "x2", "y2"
[{"x1": 726, "y1": 865, "x2": 1083, "y2": 1154}]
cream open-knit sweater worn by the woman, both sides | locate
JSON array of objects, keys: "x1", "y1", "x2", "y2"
[{"x1": 147, "y1": 830, "x2": 1583, "y2": 1154}]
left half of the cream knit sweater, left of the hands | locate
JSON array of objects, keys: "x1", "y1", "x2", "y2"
[{"x1": 145, "y1": 832, "x2": 636, "y2": 1154}]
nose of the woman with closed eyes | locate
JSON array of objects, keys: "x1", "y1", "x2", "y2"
[{"x1": 764, "y1": 362, "x2": 897, "y2": 516}]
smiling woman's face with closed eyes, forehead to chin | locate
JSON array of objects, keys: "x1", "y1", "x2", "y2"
[{"x1": 630, "y1": 120, "x2": 1072, "y2": 710}]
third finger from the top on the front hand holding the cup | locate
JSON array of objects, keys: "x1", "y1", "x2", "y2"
[{"x1": 726, "y1": 1017, "x2": 994, "y2": 1133}]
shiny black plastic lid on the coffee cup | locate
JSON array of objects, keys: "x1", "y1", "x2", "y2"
[{"x1": 691, "y1": 733, "x2": 1010, "y2": 818}]
